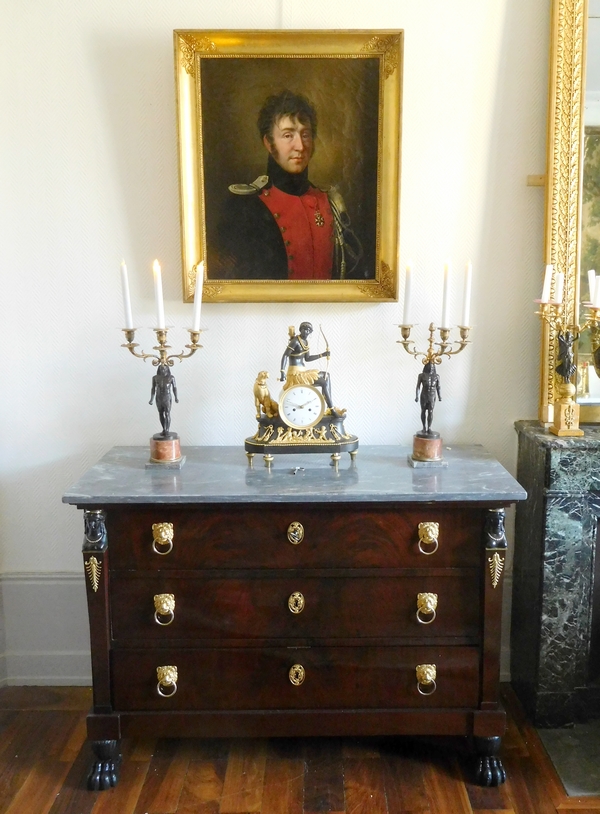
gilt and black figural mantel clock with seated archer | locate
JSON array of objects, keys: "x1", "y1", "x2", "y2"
[{"x1": 245, "y1": 322, "x2": 358, "y2": 466}]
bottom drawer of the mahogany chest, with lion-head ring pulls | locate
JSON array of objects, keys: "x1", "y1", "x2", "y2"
[{"x1": 113, "y1": 647, "x2": 479, "y2": 711}]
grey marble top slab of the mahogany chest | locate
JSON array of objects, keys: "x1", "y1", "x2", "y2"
[{"x1": 63, "y1": 445, "x2": 527, "y2": 506}]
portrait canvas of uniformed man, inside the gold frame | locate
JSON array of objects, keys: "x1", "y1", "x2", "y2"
[{"x1": 202, "y1": 59, "x2": 379, "y2": 281}]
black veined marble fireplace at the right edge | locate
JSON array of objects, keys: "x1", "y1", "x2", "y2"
[{"x1": 511, "y1": 421, "x2": 600, "y2": 727}]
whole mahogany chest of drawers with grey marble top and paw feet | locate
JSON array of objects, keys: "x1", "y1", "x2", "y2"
[{"x1": 64, "y1": 446, "x2": 525, "y2": 788}]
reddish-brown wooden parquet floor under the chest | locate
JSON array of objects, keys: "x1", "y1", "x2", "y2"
[{"x1": 0, "y1": 687, "x2": 600, "y2": 814}]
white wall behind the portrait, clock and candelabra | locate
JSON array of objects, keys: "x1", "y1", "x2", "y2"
[{"x1": 0, "y1": 0, "x2": 550, "y2": 682}]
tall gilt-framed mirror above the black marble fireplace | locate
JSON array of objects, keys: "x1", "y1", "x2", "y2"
[{"x1": 539, "y1": 0, "x2": 600, "y2": 423}]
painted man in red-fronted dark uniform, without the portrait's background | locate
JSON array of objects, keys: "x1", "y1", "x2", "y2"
[{"x1": 217, "y1": 89, "x2": 365, "y2": 280}]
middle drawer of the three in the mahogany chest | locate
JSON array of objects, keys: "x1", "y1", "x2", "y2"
[{"x1": 111, "y1": 569, "x2": 479, "y2": 643}]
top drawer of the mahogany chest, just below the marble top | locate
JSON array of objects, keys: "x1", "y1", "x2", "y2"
[{"x1": 107, "y1": 503, "x2": 483, "y2": 570}]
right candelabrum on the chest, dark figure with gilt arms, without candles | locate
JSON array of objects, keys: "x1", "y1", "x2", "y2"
[{"x1": 398, "y1": 322, "x2": 471, "y2": 467}]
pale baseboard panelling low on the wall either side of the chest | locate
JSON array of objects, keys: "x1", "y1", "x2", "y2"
[{"x1": 0, "y1": 573, "x2": 512, "y2": 686}]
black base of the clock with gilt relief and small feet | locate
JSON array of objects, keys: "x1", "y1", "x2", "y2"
[{"x1": 244, "y1": 415, "x2": 358, "y2": 456}]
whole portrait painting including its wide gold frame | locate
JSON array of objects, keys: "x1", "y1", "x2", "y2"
[{"x1": 174, "y1": 30, "x2": 403, "y2": 302}]
